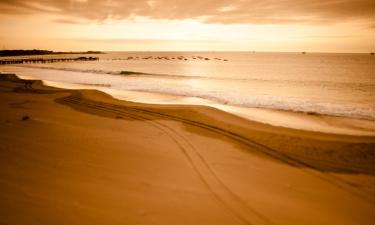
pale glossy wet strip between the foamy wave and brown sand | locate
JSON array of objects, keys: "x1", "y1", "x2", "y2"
[{"x1": 11, "y1": 70, "x2": 375, "y2": 137}]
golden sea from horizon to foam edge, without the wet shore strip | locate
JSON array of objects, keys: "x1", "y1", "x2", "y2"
[{"x1": 2, "y1": 53, "x2": 375, "y2": 120}]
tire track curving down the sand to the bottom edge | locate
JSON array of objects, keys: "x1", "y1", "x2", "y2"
[{"x1": 57, "y1": 96, "x2": 273, "y2": 225}]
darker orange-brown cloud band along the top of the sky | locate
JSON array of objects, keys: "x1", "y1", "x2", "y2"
[{"x1": 0, "y1": 0, "x2": 375, "y2": 24}]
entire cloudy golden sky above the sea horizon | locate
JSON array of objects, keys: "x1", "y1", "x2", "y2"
[{"x1": 0, "y1": 0, "x2": 375, "y2": 52}]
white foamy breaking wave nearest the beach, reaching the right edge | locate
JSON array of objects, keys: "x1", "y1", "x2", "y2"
[{"x1": 122, "y1": 87, "x2": 375, "y2": 121}]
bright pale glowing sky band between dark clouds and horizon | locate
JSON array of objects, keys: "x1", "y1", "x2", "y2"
[{"x1": 0, "y1": 0, "x2": 375, "y2": 52}]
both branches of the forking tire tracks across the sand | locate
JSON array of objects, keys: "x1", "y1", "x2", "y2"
[{"x1": 56, "y1": 94, "x2": 375, "y2": 224}]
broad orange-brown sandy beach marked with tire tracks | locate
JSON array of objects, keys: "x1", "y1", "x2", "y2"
[{"x1": 0, "y1": 75, "x2": 375, "y2": 225}]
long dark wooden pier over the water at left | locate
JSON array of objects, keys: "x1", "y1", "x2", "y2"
[{"x1": 0, "y1": 57, "x2": 99, "y2": 65}]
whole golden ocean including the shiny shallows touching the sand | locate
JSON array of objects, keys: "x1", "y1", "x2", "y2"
[{"x1": 0, "y1": 52, "x2": 375, "y2": 133}]
